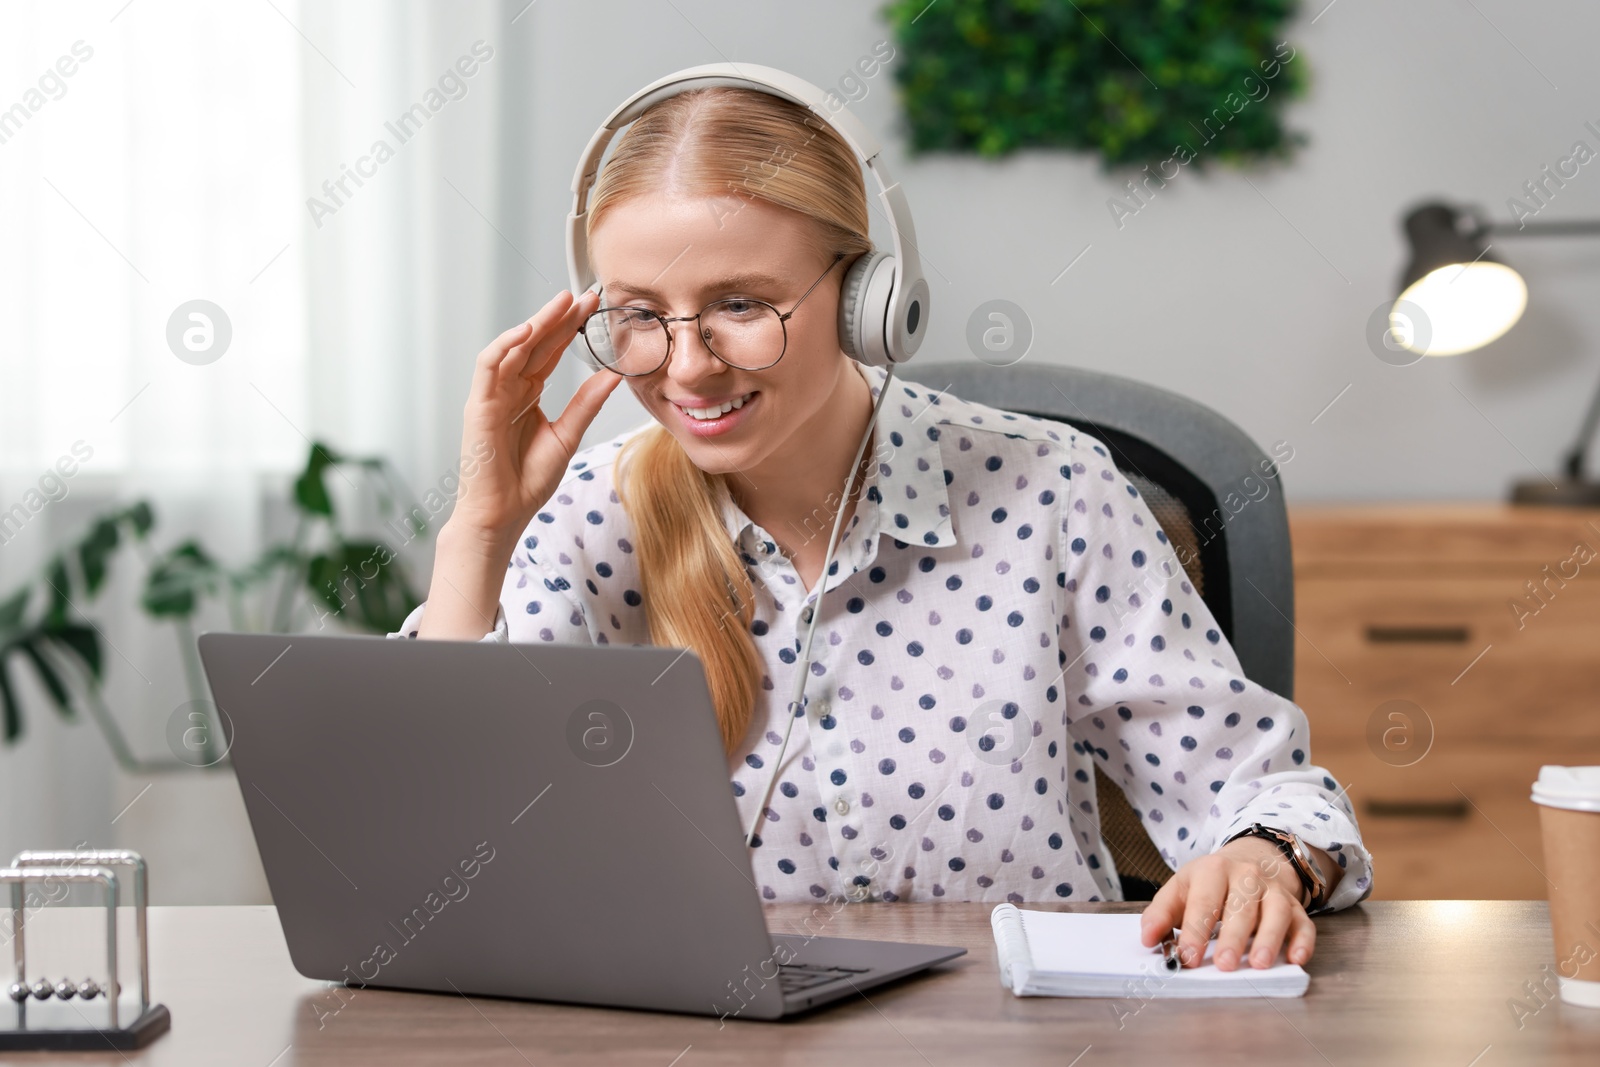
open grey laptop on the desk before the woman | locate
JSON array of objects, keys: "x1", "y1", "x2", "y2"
[{"x1": 198, "y1": 633, "x2": 965, "y2": 1019}]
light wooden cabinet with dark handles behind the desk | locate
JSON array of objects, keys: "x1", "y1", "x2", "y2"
[{"x1": 1290, "y1": 504, "x2": 1600, "y2": 899}]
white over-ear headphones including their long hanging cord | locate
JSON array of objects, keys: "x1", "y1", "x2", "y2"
[{"x1": 566, "y1": 62, "x2": 928, "y2": 846}]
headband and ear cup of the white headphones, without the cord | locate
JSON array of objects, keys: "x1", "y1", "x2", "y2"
[{"x1": 566, "y1": 62, "x2": 930, "y2": 366}]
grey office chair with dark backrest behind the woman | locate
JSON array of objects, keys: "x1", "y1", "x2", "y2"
[{"x1": 912, "y1": 362, "x2": 1294, "y2": 901}]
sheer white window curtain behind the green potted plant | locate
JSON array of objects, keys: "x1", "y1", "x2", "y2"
[{"x1": 0, "y1": 0, "x2": 522, "y2": 902}]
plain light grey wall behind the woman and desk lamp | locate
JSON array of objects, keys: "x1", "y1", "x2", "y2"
[{"x1": 502, "y1": 0, "x2": 1600, "y2": 504}]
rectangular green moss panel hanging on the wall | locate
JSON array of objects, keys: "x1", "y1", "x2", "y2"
[{"x1": 882, "y1": 0, "x2": 1307, "y2": 181}]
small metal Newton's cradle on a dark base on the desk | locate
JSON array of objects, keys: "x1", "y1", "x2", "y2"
[{"x1": 0, "y1": 849, "x2": 171, "y2": 1051}]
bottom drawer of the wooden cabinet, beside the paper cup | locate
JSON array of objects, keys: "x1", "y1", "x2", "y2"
[{"x1": 1312, "y1": 733, "x2": 1600, "y2": 901}]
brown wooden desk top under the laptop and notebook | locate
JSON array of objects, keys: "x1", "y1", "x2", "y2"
[{"x1": 15, "y1": 901, "x2": 1600, "y2": 1067}]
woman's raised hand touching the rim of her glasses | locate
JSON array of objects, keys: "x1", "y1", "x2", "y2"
[{"x1": 448, "y1": 290, "x2": 622, "y2": 553}]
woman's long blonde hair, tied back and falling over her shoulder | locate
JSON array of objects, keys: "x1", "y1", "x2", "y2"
[{"x1": 586, "y1": 86, "x2": 872, "y2": 755}]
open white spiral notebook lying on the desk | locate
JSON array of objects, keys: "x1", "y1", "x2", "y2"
[{"x1": 989, "y1": 904, "x2": 1310, "y2": 1000}]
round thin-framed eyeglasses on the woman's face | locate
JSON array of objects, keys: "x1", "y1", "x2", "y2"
[{"x1": 578, "y1": 253, "x2": 845, "y2": 378}]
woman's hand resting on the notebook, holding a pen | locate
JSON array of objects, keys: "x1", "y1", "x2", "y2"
[{"x1": 1139, "y1": 838, "x2": 1317, "y2": 971}]
